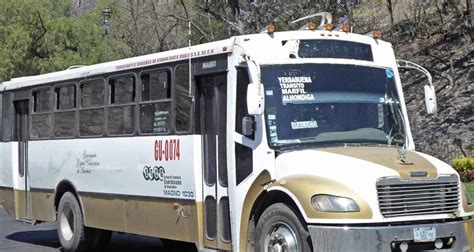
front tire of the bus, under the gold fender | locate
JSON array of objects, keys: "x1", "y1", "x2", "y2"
[{"x1": 255, "y1": 203, "x2": 312, "y2": 252}]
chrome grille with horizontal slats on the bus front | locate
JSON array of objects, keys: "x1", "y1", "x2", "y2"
[{"x1": 377, "y1": 176, "x2": 460, "y2": 217}]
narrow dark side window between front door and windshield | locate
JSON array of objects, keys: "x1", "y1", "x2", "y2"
[{"x1": 235, "y1": 67, "x2": 255, "y2": 140}]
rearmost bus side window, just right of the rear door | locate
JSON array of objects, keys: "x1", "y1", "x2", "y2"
[{"x1": 30, "y1": 88, "x2": 52, "y2": 139}]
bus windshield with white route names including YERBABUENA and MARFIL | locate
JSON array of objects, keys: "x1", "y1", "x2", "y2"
[{"x1": 261, "y1": 64, "x2": 405, "y2": 149}]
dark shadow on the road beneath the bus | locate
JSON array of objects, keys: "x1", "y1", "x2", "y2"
[{"x1": 6, "y1": 229, "x2": 195, "y2": 252}]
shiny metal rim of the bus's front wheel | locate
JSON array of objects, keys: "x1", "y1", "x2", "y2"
[{"x1": 265, "y1": 222, "x2": 298, "y2": 252}]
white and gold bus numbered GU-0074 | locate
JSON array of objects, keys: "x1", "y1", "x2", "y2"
[{"x1": 0, "y1": 12, "x2": 474, "y2": 251}]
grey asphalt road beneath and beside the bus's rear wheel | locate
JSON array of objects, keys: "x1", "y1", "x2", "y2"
[{"x1": 0, "y1": 207, "x2": 193, "y2": 252}]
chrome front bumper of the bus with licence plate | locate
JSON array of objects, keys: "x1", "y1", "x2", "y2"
[{"x1": 308, "y1": 218, "x2": 474, "y2": 251}]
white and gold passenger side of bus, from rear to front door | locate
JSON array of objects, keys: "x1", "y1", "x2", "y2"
[{"x1": 0, "y1": 41, "x2": 235, "y2": 251}]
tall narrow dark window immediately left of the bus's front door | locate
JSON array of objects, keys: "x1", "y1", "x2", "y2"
[{"x1": 174, "y1": 64, "x2": 192, "y2": 132}]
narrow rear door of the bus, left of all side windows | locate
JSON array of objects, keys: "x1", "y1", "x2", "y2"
[{"x1": 14, "y1": 100, "x2": 31, "y2": 219}]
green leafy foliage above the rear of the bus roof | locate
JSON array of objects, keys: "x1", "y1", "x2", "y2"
[{"x1": 0, "y1": 0, "x2": 129, "y2": 81}]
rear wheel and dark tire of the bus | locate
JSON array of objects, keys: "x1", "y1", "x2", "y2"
[{"x1": 57, "y1": 192, "x2": 112, "y2": 252}]
